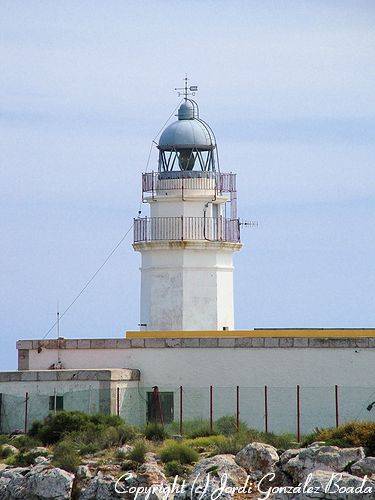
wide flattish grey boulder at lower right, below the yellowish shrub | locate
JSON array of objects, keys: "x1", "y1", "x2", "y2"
[{"x1": 282, "y1": 446, "x2": 365, "y2": 484}]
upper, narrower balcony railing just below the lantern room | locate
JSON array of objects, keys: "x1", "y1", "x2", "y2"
[{"x1": 142, "y1": 171, "x2": 236, "y2": 195}]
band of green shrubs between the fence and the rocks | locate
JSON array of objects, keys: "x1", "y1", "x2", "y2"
[{"x1": 0, "y1": 411, "x2": 375, "y2": 477}]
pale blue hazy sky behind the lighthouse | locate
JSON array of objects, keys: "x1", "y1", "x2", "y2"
[{"x1": 0, "y1": 0, "x2": 375, "y2": 370}]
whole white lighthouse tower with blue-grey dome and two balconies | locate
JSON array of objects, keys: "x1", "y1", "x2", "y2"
[{"x1": 133, "y1": 79, "x2": 242, "y2": 330}]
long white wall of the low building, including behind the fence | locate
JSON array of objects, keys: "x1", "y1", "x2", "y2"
[{"x1": 21, "y1": 348, "x2": 375, "y2": 433}]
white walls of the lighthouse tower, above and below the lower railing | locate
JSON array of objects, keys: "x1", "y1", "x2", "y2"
[{"x1": 135, "y1": 179, "x2": 238, "y2": 330}]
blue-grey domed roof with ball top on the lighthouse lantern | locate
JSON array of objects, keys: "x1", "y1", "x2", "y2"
[{"x1": 159, "y1": 100, "x2": 215, "y2": 151}]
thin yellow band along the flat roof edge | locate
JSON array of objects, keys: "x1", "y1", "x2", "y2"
[{"x1": 125, "y1": 328, "x2": 375, "y2": 339}]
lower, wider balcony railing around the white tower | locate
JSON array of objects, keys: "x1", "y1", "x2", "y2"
[{"x1": 134, "y1": 217, "x2": 240, "y2": 243}]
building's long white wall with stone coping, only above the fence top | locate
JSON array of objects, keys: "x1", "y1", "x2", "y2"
[{"x1": 22, "y1": 338, "x2": 375, "y2": 387}]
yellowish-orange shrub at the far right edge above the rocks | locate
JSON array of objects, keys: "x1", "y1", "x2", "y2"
[{"x1": 303, "y1": 421, "x2": 375, "y2": 456}]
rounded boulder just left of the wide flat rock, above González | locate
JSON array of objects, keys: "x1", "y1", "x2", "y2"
[{"x1": 235, "y1": 443, "x2": 279, "y2": 479}]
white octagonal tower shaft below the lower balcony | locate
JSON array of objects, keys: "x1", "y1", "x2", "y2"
[{"x1": 140, "y1": 242, "x2": 238, "y2": 330}]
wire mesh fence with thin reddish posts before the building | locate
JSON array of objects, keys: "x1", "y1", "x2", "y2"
[{"x1": 0, "y1": 384, "x2": 375, "y2": 439}]
